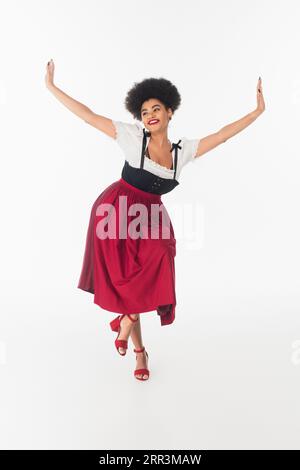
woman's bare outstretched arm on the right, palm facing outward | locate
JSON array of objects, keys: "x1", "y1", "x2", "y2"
[{"x1": 195, "y1": 77, "x2": 265, "y2": 158}]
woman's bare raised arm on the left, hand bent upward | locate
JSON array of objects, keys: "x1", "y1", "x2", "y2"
[{"x1": 45, "y1": 59, "x2": 116, "y2": 139}]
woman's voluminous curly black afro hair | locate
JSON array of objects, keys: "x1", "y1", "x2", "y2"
[{"x1": 125, "y1": 77, "x2": 181, "y2": 121}]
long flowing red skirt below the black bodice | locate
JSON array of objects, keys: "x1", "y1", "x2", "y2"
[{"x1": 77, "y1": 178, "x2": 176, "y2": 325}]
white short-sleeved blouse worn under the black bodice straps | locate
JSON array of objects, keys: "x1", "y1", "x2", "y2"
[{"x1": 112, "y1": 120, "x2": 199, "y2": 180}]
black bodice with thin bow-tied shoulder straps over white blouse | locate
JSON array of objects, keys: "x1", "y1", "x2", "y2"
[{"x1": 121, "y1": 129, "x2": 181, "y2": 194}]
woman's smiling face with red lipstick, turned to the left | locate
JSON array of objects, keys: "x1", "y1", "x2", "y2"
[{"x1": 141, "y1": 98, "x2": 172, "y2": 132}]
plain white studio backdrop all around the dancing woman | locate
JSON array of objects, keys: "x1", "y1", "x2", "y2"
[{"x1": 0, "y1": 0, "x2": 300, "y2": 449}]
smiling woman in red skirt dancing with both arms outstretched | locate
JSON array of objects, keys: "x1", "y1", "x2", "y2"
[{"x1": 45, "y1": 59, "x2": 265, "y2": 380}]
